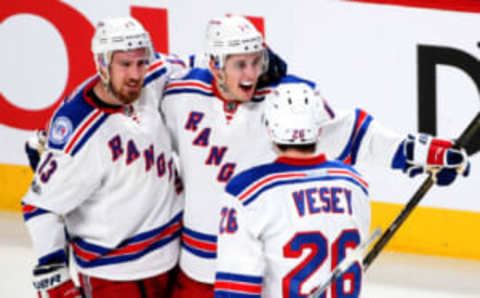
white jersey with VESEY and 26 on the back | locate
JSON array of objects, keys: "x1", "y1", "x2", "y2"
[{"x1": 215, "y1": 155, "x2": 370, "y2": 298}]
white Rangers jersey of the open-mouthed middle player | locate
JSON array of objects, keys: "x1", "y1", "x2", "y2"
[{"x1": 161, "y1": 69, "x2": 403, "y2": 283}]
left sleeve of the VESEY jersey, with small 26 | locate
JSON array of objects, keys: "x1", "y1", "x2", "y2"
[{"x1": 215, "y1": 194, "x2": 265, "y2": 298}]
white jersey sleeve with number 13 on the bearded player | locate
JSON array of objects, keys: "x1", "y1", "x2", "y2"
[{"x1": 22, "y1": 133, "x2": 103, "y2": 265}]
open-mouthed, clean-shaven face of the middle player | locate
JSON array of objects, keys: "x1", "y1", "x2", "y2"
[{"x1": 211, "y1": 52, "x2": 264, "y2": 101}]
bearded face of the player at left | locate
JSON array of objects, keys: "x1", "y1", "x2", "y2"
[{"x1": 109, "y1": 48, "x2": 148, "y2": 104}]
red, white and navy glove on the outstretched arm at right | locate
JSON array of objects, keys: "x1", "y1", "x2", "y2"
[{"x1": 402, "y1": 134, "x2": 470, "y2": 186}]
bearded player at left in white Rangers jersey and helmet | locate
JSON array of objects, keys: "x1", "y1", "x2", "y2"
[{"x1": 23, "y1": 17, "x2": 183, "y2": 298}]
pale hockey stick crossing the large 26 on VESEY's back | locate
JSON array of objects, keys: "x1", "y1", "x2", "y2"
[{"x1": 308, "y1": 227, "x2": 382, "y2": 298}]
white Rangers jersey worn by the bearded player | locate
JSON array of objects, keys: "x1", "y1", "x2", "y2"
[{"x1": 23, "y1": 54, "x2": 183, "y2": 280}]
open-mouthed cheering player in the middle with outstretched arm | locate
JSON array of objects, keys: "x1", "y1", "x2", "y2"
[{"x1": 161, "y1": 16, "x2": 466, "y2": 298}]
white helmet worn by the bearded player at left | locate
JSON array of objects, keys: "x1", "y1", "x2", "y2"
[{"x1": 92, "y1": 17, "x2": 154, "y2": 80}]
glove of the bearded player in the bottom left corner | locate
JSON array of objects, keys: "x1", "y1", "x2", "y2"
[{"x1": 33, "y1": 263, "x2": 82, "y2": 298}]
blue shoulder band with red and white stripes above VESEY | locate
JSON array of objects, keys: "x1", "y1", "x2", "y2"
[{"x1": 225, "y1": 161, "x2": 368, "y2": 206}]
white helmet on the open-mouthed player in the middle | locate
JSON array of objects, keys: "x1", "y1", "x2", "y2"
[{"x1": 205, "y1": 16, "x2": 268, "y2": 70}]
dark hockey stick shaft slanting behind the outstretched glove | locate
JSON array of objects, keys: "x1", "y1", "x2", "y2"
[{"x1": 363, "y1": 113, "x2": 480, "y2": 271}]
